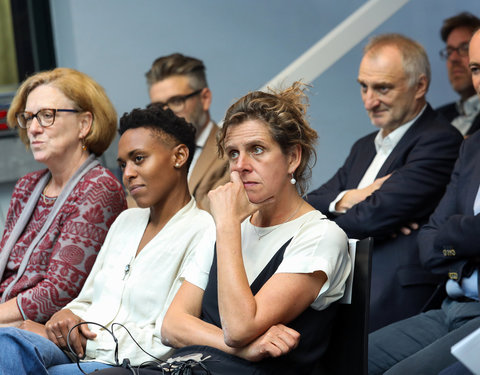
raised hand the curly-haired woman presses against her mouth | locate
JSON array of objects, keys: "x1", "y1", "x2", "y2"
[{"x1": 208, "y1": 171, "x2": 263, "y2": 224}]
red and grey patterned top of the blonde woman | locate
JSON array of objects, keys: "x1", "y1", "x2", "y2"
[{"x1": 0, "y1": 165, "x2": 126, "y2": 323}]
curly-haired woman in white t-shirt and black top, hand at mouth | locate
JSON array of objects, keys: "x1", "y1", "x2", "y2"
[{"x1": 102, "y1": 83, "x2": 351, "y2": 375}]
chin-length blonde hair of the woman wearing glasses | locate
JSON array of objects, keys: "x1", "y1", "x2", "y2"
[{"x1": 7, "y1": 68, "x2": 117, "y2": 156}]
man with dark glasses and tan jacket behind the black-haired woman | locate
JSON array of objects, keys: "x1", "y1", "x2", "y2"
[{"x1": 145, "y1": 53, "x2": 230, "y2": 211}]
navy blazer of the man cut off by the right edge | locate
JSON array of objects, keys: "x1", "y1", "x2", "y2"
[{"x1": 418, "y1": 132, "x2": 480, "y2": 280}]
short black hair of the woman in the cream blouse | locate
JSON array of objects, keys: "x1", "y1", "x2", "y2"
[{"x1": 118, "y1": 103, "x2": 196, "y2": 171}]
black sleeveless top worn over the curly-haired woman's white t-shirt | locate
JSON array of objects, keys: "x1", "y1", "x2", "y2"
[{"x1": 195, "y1": 239, "x2": 337, "y2": 375}]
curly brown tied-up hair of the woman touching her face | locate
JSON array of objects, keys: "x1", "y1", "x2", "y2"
[{"x1": 217, "y1": 81, "x2": 318, "y2": 195}]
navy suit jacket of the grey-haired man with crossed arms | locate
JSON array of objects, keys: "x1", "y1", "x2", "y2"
[{"x1": 306, "y1": 105, "x2": 463, "y2": 331}]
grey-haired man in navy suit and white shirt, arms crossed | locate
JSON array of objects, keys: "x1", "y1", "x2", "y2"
[{"x1": 307, "y1": 34, "x2": 462, "y2": 331}]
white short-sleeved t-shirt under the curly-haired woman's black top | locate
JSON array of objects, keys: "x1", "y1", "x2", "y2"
[{"x1": 185, "y1": 210, "x2": 351, "y2": 310}]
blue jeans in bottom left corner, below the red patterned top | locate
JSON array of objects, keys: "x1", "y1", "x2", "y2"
[{"x1": 0, "y1": 327, "x2": 111, "y2": 375}]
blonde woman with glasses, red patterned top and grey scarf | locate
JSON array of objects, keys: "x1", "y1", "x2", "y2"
[{"x1": 0, "y1": 68, "x2": 126, "y2": 332}]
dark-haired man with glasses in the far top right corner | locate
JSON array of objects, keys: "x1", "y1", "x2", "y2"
[{"x1": 437, "y1": 12, "x2": 480, "y2": 136}]
